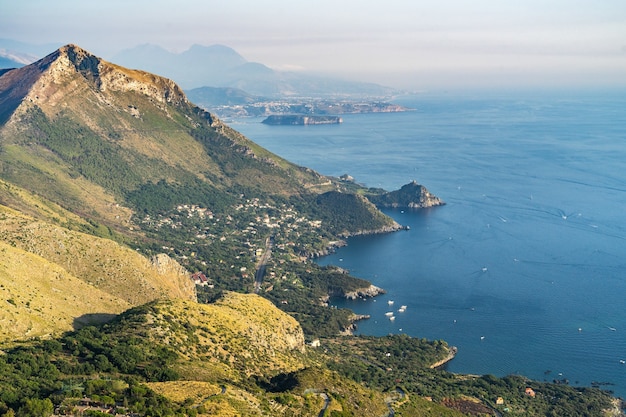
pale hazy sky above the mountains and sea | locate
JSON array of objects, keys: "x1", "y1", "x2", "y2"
[{"x1": 0, "y1": 0, "x2": 626, "y2": 89}]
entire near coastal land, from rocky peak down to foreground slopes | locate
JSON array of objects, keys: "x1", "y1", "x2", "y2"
[{"x1": 0, "y1": 45, "x2": 619, "y2": 417}]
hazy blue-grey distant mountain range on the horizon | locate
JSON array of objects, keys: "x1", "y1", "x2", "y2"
[{"x1": 111, "y1": 45, "x2": 393, "y2": 97}]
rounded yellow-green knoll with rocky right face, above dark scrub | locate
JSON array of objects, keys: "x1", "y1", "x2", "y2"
[{"x1": 142, "y1": 293, "x2": 305, "y2": 376}]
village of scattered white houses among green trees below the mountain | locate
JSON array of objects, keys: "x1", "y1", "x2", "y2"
[{"x1": 139, "y1": 197, "x2": 327, "y2": 288}]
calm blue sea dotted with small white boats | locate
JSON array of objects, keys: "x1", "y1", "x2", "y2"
[{"x1": 231, "y1": 91, "x2": 626, "y2": 397}]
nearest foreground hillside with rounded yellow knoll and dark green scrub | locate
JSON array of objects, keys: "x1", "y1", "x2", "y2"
[{"x1": 0, "y1": 293, "x2": 611, "y2": 417}]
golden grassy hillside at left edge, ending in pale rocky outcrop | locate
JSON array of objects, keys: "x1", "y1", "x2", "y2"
[{"x1": 0, "y1": 200, "x2": 196, "y2": 345}]
